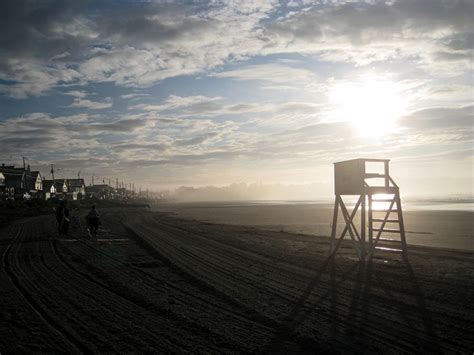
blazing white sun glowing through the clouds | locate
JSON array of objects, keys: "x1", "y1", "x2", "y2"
[{"x1": 329, "y1": 77, "x2": 406, "y2": 138}]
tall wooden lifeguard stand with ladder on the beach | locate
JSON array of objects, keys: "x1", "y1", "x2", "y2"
[{"x1": 331, "y1": 159, "x2": 407, "y2": 261}]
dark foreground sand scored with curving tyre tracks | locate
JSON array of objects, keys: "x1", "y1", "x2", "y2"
[{"x1": 0, "y1": 209, "x2": 474, "y2": 353}]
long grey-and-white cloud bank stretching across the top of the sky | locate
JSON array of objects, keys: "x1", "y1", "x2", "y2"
[{"x1": 0, "y1": 0, "x2": 474, "y2": 98}]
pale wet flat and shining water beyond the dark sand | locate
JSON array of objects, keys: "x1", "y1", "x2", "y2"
[{"x1": 155, "y1": 199, "x2": 474, "y2": 251}]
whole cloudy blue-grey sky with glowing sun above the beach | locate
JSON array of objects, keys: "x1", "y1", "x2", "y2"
[{"x1": 0, "y1": 0, "x2": 474, "y2": 198}]
